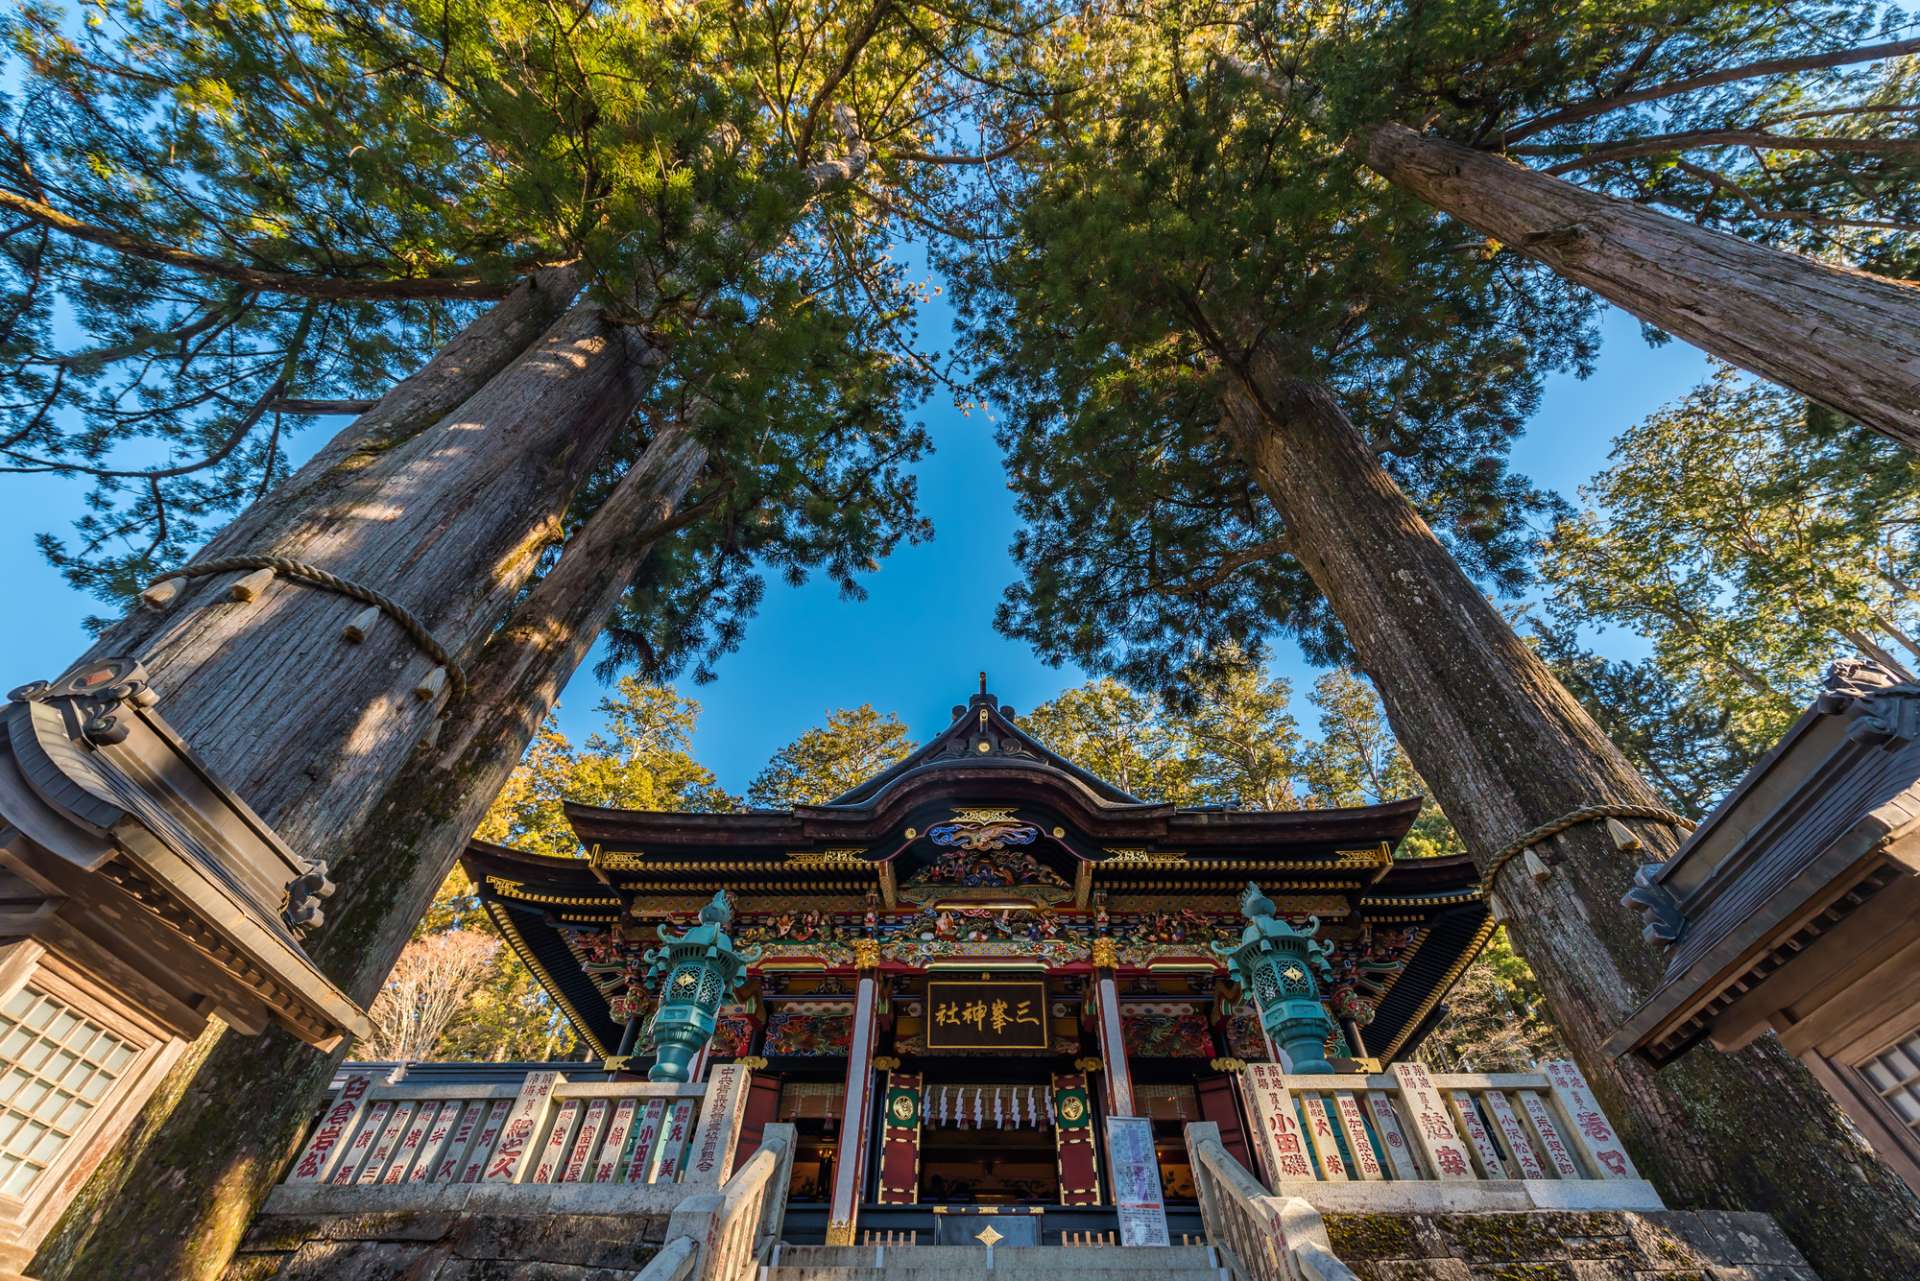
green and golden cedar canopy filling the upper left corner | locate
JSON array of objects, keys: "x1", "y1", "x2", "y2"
[{"x1": 0, "y1": 0, "x2": 995, "y2": 645}]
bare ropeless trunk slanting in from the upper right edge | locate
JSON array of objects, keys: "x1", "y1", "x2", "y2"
[{"x1": 1354, "y1": 125, "x2": 1920, "y2": 449}]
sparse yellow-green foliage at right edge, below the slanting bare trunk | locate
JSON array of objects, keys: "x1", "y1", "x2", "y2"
[{"x1": 1544, "y1": 369, "x2": 1920, "y2": 752}]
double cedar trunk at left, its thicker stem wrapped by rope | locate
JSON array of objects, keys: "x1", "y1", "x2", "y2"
[{"x1": 35, "y1": 293, "x2": 675, "y2": 1281}]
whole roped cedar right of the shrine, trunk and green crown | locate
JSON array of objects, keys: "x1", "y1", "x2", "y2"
[{"x1": 952, "y1": 6, "x2": 1920, "y2": 1277}]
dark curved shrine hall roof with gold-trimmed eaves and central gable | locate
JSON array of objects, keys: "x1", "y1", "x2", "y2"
[{"x1": 463, "y1": 689, "x2": 1492, "y2": 1058}]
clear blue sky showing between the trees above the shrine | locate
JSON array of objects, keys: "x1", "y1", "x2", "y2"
[{"x1": 0, "y1": 309, "x2": 1707, "y2": 791}]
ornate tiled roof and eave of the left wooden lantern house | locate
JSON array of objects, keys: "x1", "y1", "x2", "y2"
[{"x1": 0, "y1": 659, "x2": 371, "y2": 1049}]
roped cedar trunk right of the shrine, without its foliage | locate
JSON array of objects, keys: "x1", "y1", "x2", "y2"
[{"x1": 1227, "y1": 355, "x2": 1920, "y2": 1281}]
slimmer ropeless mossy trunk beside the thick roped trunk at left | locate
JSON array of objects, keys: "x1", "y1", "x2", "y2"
[{"x1": 33, "y1": 401, "x2": 707, "y2": 1281}]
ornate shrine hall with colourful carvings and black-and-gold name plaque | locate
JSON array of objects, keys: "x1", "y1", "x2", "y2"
[{"x1": 465, "y1": 689, "x2": 1492, "y2": 1243}]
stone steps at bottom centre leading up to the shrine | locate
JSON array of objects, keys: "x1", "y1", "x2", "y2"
[{"x1": 758, "y1": 1245, "x2": 1229, "y2": 1281}]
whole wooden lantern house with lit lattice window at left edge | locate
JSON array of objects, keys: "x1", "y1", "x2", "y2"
[{"x1": 0, "y1": 659, "x2": 369, "y2": 1281}]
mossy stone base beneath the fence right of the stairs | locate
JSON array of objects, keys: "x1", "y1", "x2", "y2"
[{"x1": 1325, "y1": 1210, "x2": 1820, "y2": 1281}]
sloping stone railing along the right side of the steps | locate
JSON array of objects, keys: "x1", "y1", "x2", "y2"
[{"x1": 1182, "y1": 1122, "x2": 1357, "y2": 1281}]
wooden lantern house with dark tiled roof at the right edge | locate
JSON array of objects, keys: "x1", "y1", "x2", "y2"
[{"x1": 1609, "y1": 661, "x2": 1920, "y2": 1191}]
